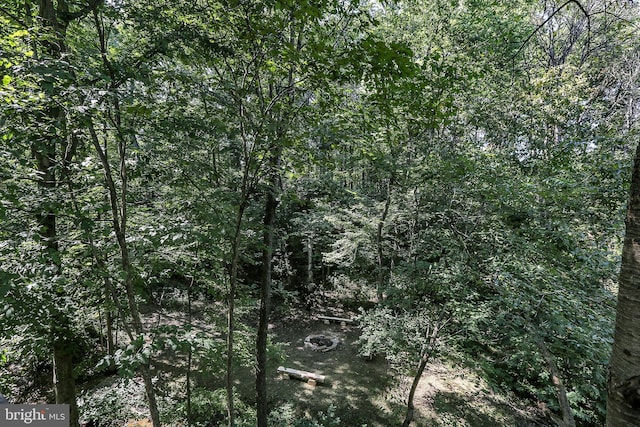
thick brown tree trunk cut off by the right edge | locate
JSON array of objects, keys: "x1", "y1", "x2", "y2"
[{"x1": 607, "y1": 145, "x2": 640, "y2": 427}]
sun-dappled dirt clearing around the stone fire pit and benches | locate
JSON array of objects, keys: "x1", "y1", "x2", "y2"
[{"x1": 255, "y1": 319, "x2": 541, "y2": 427}]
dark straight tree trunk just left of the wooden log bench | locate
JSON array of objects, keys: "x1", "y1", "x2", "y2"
[{"x1": 256, "y1": 153, "x2": 282, "y2": 427}]
